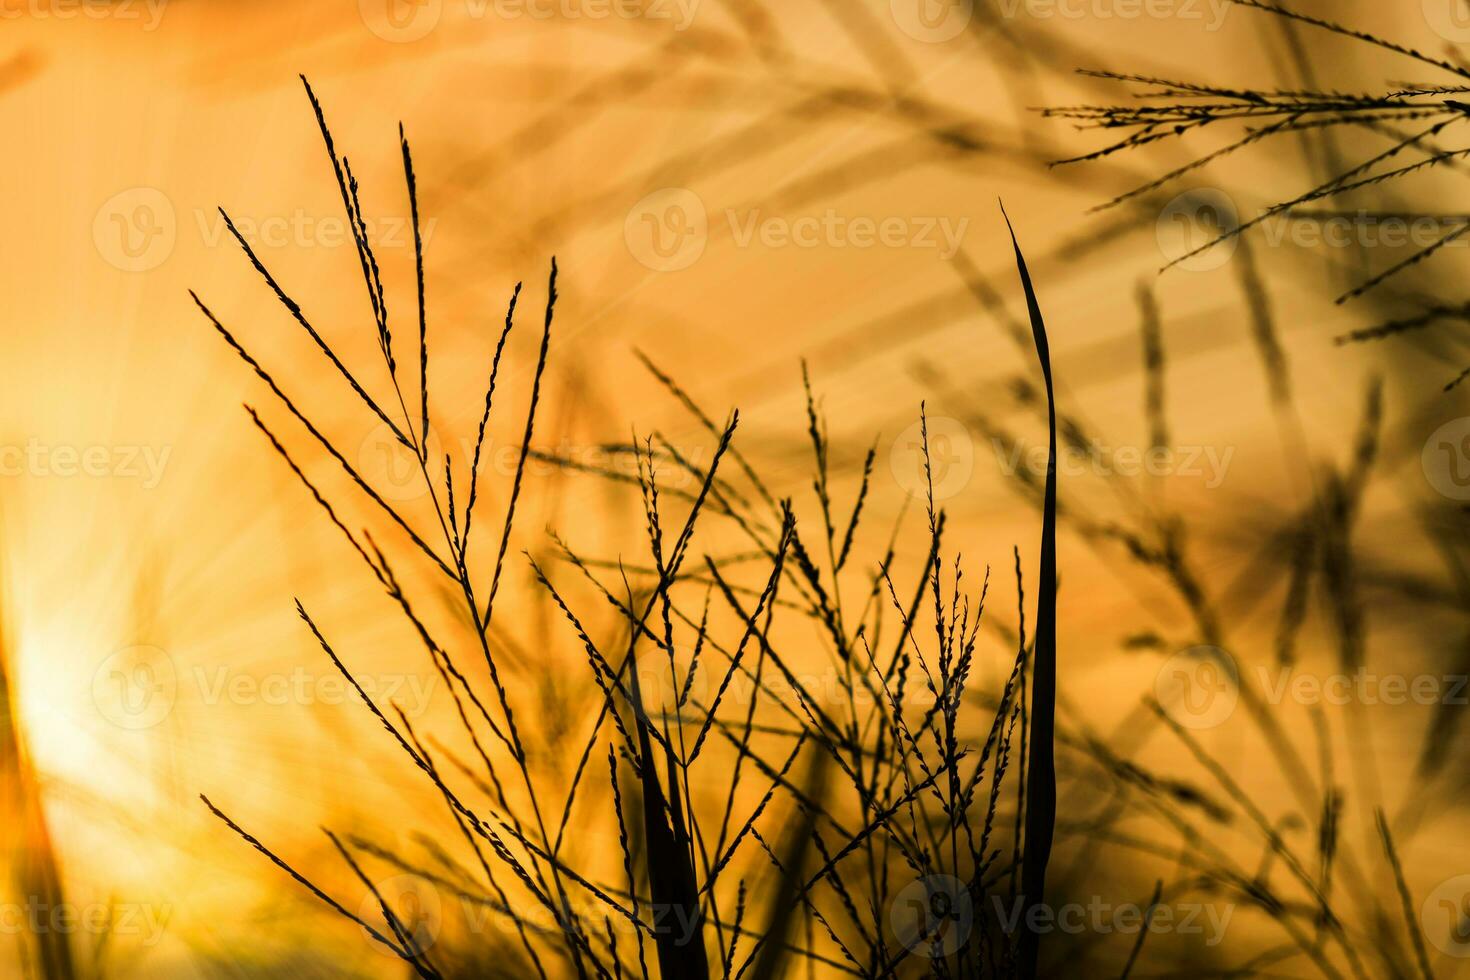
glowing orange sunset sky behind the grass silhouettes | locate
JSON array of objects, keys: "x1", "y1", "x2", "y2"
[{"x1": 0, "y1": 0, "x2": 1470, "y2": 977}]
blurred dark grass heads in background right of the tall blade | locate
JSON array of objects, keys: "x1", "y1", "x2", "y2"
[{"x1": 925, "y1": 227, "x2": 1455, "y2": 977}]
